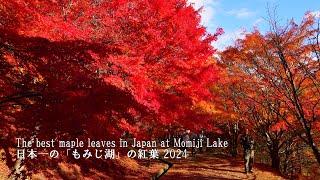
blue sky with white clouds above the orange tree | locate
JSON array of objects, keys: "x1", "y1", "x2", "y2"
[{"x1": 188, "y1": 0, "x2": 320, "y2": 50}]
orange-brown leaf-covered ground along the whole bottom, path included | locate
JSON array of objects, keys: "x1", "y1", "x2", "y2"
[{"x1": 0, "y1": 151, "x2": 285, "y2": 180}]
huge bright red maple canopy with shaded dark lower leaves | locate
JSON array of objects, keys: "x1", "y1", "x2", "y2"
[{"x1": 0, "y1": 0, "x2": 222, "y2": 142}]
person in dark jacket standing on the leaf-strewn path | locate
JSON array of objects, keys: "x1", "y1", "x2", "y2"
[{"x1": 240, "y1": 129, "x2": 254, "y2": 173}]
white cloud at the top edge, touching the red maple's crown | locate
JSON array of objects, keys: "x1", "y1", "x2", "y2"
[{"x1": 188, "y1": 0, "x2": 219, "y2": 27}]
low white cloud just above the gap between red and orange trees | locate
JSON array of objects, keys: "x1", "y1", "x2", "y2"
[{"x1": 212, "y1": 28, "x2": 246, "y2": 51}]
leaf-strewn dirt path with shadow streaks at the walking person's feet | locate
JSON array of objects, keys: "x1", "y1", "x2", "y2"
[{"x1": 160, "y1": 155, "x2": 284, "y2": 180}]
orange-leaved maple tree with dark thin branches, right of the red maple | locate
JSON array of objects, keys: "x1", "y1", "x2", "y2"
[{"x1": 215, "y1": 13, "x2": 320, "y2": 165}]
